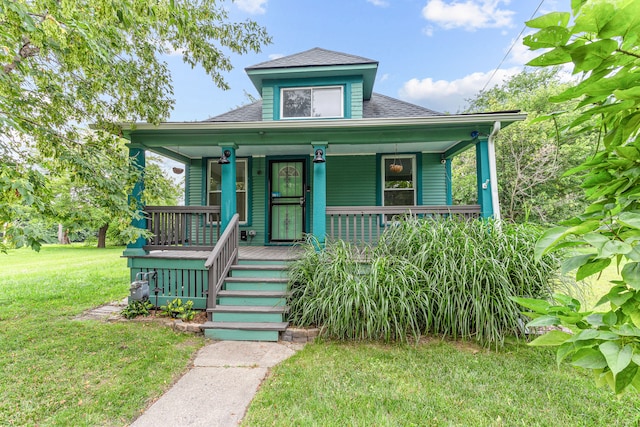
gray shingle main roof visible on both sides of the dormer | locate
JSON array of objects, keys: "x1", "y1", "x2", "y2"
[{"x1": 205, "y1": 93, "x2": 443, "y2": 122}]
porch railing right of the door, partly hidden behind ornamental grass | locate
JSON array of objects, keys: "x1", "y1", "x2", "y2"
[{"x1": 327, "y1": 205, "x2": 480, "y2": 243}]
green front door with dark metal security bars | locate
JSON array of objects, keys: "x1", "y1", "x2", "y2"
[{"x1": 269, "y1": 159, "x2": 306, "y2": 242}]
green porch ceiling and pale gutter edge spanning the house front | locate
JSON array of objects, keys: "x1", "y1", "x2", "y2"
[{"x1": 122, "y1": 112, "x2": 526, "y2": 161}]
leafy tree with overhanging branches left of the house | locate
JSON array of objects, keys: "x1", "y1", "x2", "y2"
[{"x1": 0, "y1": 0, "x2": 270, "y2": 251}]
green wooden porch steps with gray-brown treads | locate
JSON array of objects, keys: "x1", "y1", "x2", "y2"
[{"x1": 202, "y1": 260, "x2": 289, "y2": 341}]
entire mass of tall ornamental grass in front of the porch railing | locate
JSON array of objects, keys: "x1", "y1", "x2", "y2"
[{"x1": 289, "y1": 217, "x2": 559, "y2": 346}]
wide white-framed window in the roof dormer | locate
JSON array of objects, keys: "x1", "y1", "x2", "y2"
[{"x1": 280, "y1": 86, "x2": 344, "y2": 119}]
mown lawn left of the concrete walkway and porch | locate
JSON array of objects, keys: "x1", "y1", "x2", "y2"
[{"x1": 0, "y1": 246, "x2": 203, "y2": 426}]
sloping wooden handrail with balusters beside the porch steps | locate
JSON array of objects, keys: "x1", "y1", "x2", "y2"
[{"x1": 204, "y1": 214, "x2": 240, "y2": 320}]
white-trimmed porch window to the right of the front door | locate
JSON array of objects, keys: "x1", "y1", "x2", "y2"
[{"x1": 382, "y1": 154, "x2": 416, "y2": 206}]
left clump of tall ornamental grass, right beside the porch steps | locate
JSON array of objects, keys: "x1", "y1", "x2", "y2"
[{"x1": 289, "y1": 240, "x2": 429, "y2": 341}]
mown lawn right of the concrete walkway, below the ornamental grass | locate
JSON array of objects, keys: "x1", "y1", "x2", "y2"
[{"x1": 243, "y1": 339, "x2": 640, "y2": 426}]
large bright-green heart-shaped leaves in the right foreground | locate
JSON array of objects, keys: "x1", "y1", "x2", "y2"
[{"x1": 516, "y1": 0, "x2": 640, "y2": 393}]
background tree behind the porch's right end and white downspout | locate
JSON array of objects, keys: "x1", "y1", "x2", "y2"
[{"x1": 453, "y1": 68, "x2": 594, "y2": 223}]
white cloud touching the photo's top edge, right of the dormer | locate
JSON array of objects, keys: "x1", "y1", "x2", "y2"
[{"x1": 422, "y1": 0, "x2": 515, "y2": 31}]
